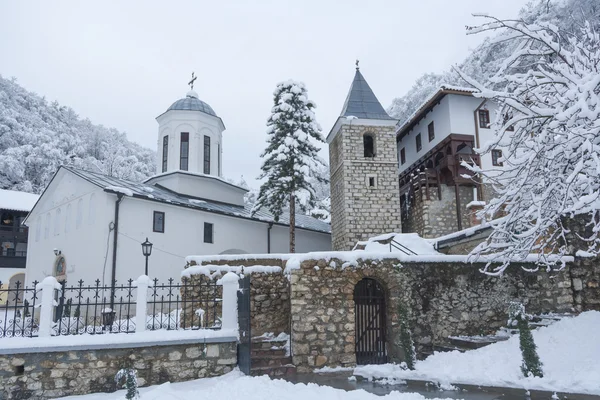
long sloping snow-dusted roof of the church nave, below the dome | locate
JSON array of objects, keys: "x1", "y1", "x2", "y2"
[{"x1": 61, "y1": 166, "x2": 331, "y2": 233}]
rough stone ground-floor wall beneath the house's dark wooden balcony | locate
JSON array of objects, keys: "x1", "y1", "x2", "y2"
[{"x1": 403, "y1": 185, "x2": 473, "y2": 238}]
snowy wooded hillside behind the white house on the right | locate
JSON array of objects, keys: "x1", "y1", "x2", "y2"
[{"x1": 388, "y1": 0, "x2": 600, "y2": 123}]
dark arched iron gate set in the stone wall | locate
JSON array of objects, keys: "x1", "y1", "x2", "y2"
[{"x1": 354, "y1": 278, "x2": 387, "y2": 365}]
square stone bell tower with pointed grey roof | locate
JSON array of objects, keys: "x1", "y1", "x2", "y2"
[{"x1": 327, "y1": 62, "x2": 401, "y2": 250}]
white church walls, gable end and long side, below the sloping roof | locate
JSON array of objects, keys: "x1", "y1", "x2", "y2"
[{"x1": 26, "y1": 170, "x2": 331, "y2": 285}]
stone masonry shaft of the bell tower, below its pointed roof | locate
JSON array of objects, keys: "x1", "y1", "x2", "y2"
[{"x1": 329, "y1": 125, "x2": 401, "y2": 250}]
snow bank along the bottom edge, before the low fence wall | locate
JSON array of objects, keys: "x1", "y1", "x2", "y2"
[{"x1": 58, "y1": 371, "x2": 450, "y2": 400}]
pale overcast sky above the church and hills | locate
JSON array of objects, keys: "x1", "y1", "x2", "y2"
[{"x1": 0, "y1": 0, "x2": 528, "y2": 186}]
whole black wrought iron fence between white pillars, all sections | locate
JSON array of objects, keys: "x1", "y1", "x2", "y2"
[{"x1": 0, "y1": 279, "x2": 222, "y2": 338}]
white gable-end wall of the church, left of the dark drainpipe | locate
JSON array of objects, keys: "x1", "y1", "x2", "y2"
[{"x1": 25, "y1": 169, "x2": 114, "y2": 284}]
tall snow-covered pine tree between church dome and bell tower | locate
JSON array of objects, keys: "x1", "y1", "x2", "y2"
[{"x1": 253, "y1": 80, "x2": 326, "y2": 253}]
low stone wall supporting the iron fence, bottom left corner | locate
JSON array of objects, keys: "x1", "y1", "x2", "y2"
[{"x1": 0, "y1": 339, "x2": 237, "y2": 400}]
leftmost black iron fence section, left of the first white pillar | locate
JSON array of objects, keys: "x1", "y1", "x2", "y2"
[{"x1": 0, "y1": 281, "x2": 39, "y2": 338}]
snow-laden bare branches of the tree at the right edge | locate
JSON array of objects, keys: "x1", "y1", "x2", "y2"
[{"x1": 459, "y1": 15, "x2": 600, "y2": 274}]
